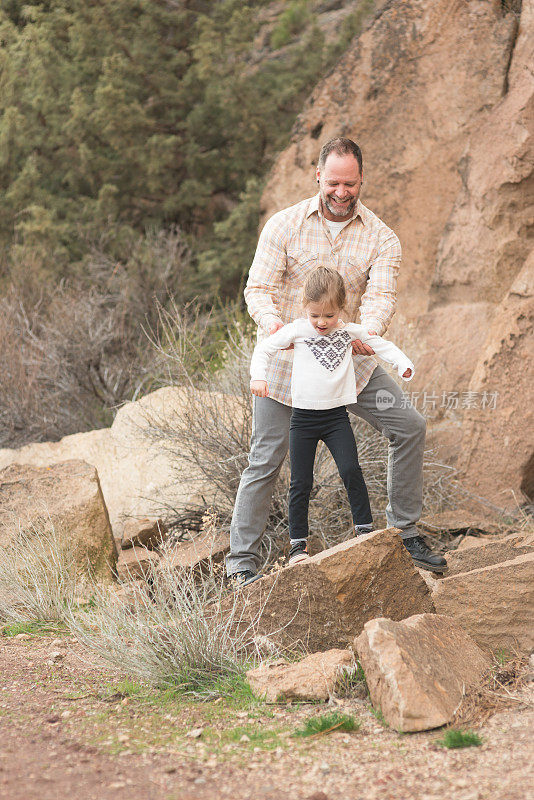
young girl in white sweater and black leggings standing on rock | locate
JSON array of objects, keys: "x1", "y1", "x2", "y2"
[{"x1": 250, "y1": 267, "x2": 414, "y2": 564}]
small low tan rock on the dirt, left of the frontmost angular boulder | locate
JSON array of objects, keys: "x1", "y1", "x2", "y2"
[{"x1": 247, "y1": 650, "x2": 355, "y2": 703}]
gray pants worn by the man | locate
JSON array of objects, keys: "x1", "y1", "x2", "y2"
[{"x1": 226, "y1": 366, "x2": 426, "y2": 575}]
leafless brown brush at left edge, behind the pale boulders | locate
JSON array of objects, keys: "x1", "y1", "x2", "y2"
[{"x1": 0, "y1": 228, "x2": 190, "y2": 447}]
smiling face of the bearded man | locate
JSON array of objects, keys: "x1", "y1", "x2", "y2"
[{"x1": 317, "y1": 153, "x2": 362, "y2": 222}]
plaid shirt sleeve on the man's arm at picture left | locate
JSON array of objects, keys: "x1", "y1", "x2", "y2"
[{"x1": 244, "y1": 213, "x2": 287, "y2": 332}]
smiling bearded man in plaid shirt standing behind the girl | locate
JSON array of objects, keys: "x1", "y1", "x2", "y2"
[{"x1": 227, "y1": 138, "x2": 446, "y2": 585}]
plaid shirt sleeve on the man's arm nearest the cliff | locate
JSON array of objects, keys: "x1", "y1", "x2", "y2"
[{"x1": 360, "y1": 228, "x2": 402, "y2": 336}]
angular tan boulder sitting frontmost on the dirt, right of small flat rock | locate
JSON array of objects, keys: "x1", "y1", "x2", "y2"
[{"x1": 354, "y1": 614, "x2": 490, "y2": 732}]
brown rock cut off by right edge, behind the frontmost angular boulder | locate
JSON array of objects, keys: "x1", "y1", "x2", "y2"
[{"x1": 432, "y1": 551, "x2": 534, "y2": 653}]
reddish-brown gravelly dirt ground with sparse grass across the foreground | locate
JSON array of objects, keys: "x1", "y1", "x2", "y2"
[{"x1": 0, "y1": 636, "x2": 534, "y2": 800}]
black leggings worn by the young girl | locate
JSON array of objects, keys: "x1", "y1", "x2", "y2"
[{"x1": 289, "y1": 406, "x2": 373, "y2": 539}]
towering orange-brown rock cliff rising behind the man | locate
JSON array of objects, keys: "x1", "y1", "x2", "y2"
[{"x1": 262, "y1": 0, "x2": 534, "y2": 506}]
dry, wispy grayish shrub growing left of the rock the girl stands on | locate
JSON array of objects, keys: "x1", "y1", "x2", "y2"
[{"x1": 69, "y1": 532, "x2": 276, "y2": 699}]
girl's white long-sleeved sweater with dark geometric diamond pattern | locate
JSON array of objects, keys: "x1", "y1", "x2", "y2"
[{"x1": 250, "y1": 319, "x2": 414, "y2": 409}]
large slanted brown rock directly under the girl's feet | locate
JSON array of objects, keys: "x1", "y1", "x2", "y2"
[{"x1": 232, "y1": 528, "x2": 434, "y2": 652}]
